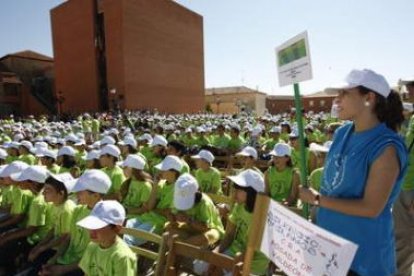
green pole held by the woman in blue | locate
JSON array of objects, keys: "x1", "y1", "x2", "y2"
[{"x1": 293, "y1": 83, "x2": 309, "y2": 219}]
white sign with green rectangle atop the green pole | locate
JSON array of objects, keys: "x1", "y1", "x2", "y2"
[{"x1": 276, "y1": 32, "x2": 312, "y2": 86}]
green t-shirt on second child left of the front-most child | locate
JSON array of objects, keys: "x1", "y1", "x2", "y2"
[{"x1": 52, "y1": 200, "x2": 76, "y2": 237}]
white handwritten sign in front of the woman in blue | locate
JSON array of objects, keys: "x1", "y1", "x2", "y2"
[{"x1": 260, "y1": 200, "x2": 358, "y2": 276}]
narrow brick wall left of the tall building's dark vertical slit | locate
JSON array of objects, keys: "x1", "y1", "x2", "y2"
[{"x1": 51, "y1": 0, "x2": 99, "y2": 112}]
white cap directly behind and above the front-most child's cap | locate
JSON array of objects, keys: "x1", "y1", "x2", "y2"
[{"x1": 72, "y1": 169, "x2": 112, "y2": 194}]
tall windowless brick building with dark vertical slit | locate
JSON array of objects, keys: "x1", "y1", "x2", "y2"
[{"x1": 51, "y1": 0, "x2": 204, "y2": 112}]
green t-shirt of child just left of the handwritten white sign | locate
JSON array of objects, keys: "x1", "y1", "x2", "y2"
[{"x1": 229, "y1": 203, "x2": 269, "y2": 275}]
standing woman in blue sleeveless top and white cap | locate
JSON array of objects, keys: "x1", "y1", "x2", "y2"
[{"x1": 300, "y1": 69, "x2": 407, "y2": 276}]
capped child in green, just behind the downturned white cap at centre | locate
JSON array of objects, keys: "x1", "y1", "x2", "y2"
[{"x1": 191, "y1": 150, "x2": 223, "y2": 194}]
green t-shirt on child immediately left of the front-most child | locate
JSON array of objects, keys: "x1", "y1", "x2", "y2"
[{"x1": 57, "y1": 205, "x2": 91, "y2": 265}]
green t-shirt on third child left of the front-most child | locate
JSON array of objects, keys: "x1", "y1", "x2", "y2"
[{"x1": 26, "y1": 194, "x2": 53, "y2": 245}]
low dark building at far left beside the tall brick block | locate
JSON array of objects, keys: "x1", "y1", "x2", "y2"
[{"x1": 0, "y1": 50, "x2": 56, "y2": 116}]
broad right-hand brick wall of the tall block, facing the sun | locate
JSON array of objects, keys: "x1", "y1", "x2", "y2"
[{"x1": 122, "y1": 0, "x2": 204, "y2": 112}]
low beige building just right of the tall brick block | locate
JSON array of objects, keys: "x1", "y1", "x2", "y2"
[{"x1": 205, "y1": 86, "x2": 267, "y2": 115}]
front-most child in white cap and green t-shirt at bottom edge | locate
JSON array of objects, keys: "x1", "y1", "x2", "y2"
[{"x1": 78, "y1": 200, "x2": 137, "y2": 276}]
